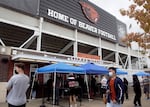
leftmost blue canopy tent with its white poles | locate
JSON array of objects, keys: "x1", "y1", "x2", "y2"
[{"x1": 30, "y1": 62, "x2": 85, "y2": 104}]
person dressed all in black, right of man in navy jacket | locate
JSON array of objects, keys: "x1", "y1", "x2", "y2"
[{"x1": 133, "y1": 75, "x2": 142, "y2": 107}]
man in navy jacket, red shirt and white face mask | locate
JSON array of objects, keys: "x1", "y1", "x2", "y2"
[{"x1": 106, "y1": 67, "x2": 124, "y2": 107}]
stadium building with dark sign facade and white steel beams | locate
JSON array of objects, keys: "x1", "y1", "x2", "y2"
[{"x1": 0, "y1": 0, "x2": 147, "y2": 85}]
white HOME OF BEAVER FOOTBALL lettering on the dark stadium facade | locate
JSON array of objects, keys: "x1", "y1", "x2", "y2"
[{"x1": 48, "y1": 9, "x2": 116, "y2": 41}]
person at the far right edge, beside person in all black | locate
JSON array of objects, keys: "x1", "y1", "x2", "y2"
[{"x1": 143, "y1": 76, "x2": 150, "y2": 100}]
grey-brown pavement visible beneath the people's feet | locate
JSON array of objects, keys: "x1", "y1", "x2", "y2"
[{"x1": 0, "y1": 93, "x2": 150, "y2": 107}]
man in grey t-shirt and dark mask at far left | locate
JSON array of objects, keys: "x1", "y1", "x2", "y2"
[{"x1": 7, "y1": 63, "x2": 29, "y2": 107}]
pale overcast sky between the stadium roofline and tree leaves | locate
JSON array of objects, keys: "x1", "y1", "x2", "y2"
[{"x1": 89, "y1": 0, "x2": 142, "y2": 32}]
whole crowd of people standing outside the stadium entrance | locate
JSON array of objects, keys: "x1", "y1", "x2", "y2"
[{"x1": 7, "y1": 63, "x2": 149, "y2": 107}]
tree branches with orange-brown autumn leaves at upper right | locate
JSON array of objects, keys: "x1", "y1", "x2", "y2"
[{"x1": 120, "y1": 0, "x2": 150, "y2": 50}]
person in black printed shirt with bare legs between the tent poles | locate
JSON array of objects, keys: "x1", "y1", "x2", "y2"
[{"x1": 68, "y1": 74, "x2": 77, "y2": 107}]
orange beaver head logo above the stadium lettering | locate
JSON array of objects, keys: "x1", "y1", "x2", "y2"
[{"x1": 79, "y1": 1, "x2": 99, "y2": 23}]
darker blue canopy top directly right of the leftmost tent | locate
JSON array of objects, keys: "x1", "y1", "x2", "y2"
[{"x1": 80, "y1": 63, "x2": 108, "y2": 74}]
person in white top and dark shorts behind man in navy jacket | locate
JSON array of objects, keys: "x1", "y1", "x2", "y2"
[{"x1": 101, "y1": 75, "x2": 107, "y2": 104}]
